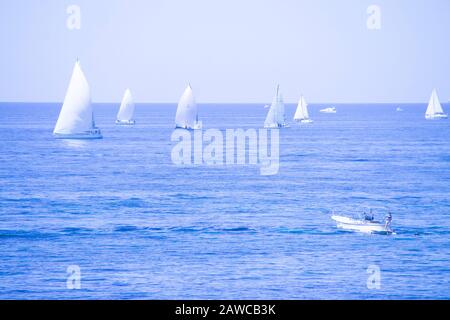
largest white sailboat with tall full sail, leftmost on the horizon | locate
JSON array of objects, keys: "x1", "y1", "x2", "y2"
[{"x1": 53, "y1": 61, "x2": 102, "y2": 139}]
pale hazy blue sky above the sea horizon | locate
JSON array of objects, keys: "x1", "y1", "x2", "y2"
[{"x1": 0, "y1": 0, "x2": 450, "y2": 103}]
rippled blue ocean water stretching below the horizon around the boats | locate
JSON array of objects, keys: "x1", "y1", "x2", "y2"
[{"x1": 0, "y1": 104, "x2": 450, "y2": 299}]
